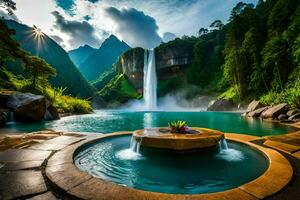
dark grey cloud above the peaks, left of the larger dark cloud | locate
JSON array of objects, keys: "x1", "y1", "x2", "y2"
[{"x1": 52, "y1": 11, "x2": 100, "y2": 48}]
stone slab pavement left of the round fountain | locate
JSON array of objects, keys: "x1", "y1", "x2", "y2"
[{"x1": 0, "y1": 131, "x2": 92, "y2": 200}]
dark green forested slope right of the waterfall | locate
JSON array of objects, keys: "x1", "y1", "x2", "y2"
[{"x1": 100, "y1": 0, "x2": 300, "y2": 108}]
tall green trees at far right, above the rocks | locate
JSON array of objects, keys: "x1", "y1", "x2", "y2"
[{"x1": 212, "y1": 0, "x2": 300, "y2": 107}]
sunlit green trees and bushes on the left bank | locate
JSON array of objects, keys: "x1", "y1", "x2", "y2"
[{"x1": 0, "y1": 4, "x2": 92, "y2": 113}]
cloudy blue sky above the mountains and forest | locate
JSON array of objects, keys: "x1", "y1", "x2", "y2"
[{"x1": 0, "y1": 0, "x2": 258, "y2": 50}]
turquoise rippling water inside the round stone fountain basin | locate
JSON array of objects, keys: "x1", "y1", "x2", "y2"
[{"x1": 74, "y1": 136, "x2": 268, "y2": 194}]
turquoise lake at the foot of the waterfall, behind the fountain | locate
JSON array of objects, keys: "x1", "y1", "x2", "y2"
[{"x1": 0, "y1": 110, "x2": 294, "y2": 136}]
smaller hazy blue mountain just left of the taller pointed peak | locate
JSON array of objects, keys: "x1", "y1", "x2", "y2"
[{"x1": 68, "y1": 45, "x2": 97, "y2": 67}]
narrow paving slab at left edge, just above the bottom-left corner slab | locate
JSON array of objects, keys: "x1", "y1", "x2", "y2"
[{"x1": 0, "y1": 160, "x2": 43, "y2": 172}]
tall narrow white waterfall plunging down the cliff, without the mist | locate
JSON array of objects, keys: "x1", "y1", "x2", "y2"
[{"x1": 143, "y1": 49, "x2": 157, "y2": 110}]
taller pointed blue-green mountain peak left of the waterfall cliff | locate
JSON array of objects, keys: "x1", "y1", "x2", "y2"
[{"x1": 79, "y1": 35, "x2": 130, "y2": 80}]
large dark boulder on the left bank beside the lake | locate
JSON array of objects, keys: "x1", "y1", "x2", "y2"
[{"x1": 6, "y1": 93, "x2": 46, "y2": 122}]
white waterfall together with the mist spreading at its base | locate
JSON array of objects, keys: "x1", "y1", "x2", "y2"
[{"x1": 122, "y1": 49, "x2": 213, "y2": 112}]
